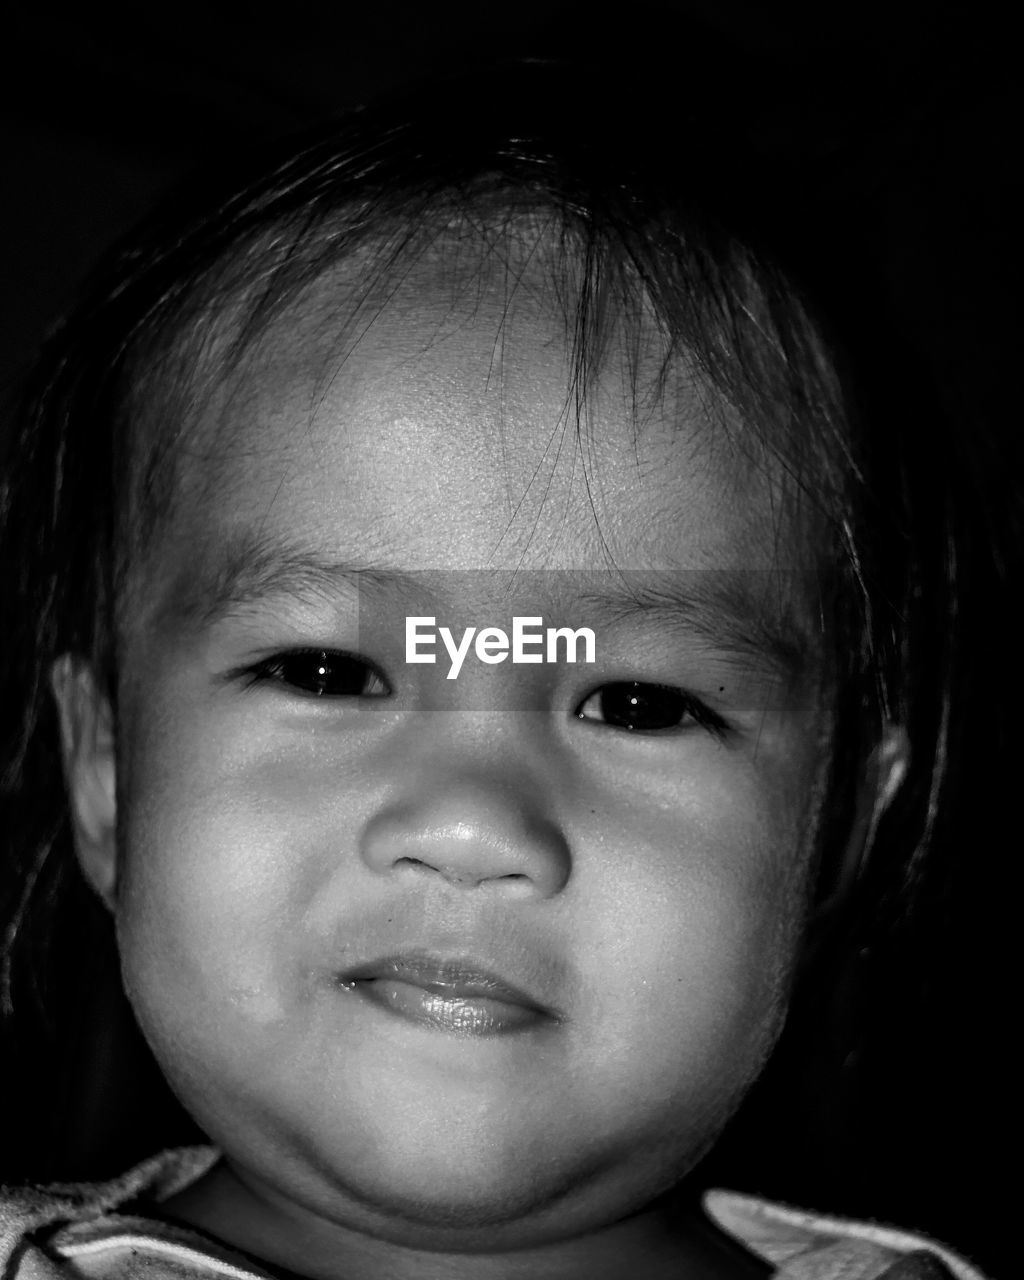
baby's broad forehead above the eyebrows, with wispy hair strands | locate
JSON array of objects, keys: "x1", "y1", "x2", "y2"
[{"x1": 144, "y1": 232, "x2": 806, "y2": 586}]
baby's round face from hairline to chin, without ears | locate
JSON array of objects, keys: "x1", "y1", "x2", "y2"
[{"x1": 106, "y1": 247, "x2": 822, "y2": 1242}]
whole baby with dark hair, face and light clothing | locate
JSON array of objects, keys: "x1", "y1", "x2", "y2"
[{"x1": 3, "y1": 55, "x2": 993, "y2": 1280}]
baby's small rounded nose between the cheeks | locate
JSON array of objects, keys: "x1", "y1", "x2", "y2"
[{"x1": 360, "y1": 773, "x2": 572, "y2": 899}]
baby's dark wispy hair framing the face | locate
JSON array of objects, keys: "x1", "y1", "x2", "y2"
[{"x1": 3, "y1": 49, "x2": 983, "y2": 1223}]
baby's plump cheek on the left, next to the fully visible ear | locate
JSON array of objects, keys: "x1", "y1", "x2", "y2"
[{"x1": 116, "y1": 709, "x2": 344, "y2": 1041}]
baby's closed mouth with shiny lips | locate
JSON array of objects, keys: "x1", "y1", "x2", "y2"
[{"x1": 338, "y1": 955, "x2": 561, "y2": 1037}]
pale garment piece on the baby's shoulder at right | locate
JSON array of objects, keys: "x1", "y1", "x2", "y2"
[{"x1": 704, "y1": 1190, "x2": 986, "y2": 1280}]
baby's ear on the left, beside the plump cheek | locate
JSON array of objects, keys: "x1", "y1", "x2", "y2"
[{"x1": 50, "y1": 654, "x2": 118, "y2": 910}]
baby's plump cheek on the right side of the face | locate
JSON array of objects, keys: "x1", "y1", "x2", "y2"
[{"x1": 576, "y1": 752, "x2": 808, "y2": 1125}]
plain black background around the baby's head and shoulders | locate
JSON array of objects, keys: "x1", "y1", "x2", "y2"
[{"x1": 0, "y1": 0, "x2": 1024, "y2": 1275}]
